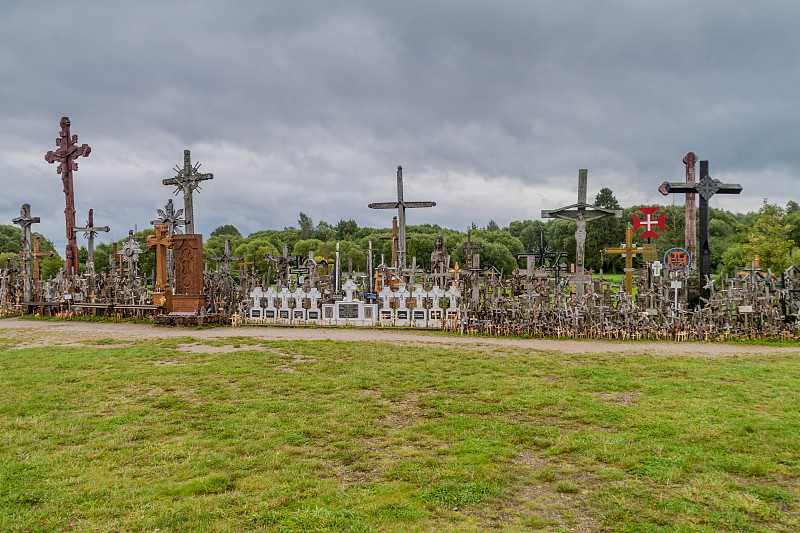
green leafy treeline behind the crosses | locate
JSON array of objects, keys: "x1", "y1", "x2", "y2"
[{"x1": 0, "y1": 188, "x2": 800, "y2": 279}]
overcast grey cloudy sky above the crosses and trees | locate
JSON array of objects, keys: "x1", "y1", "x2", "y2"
[{"x1": 0, "y1": 0, "x2": 800, "y2": 255}]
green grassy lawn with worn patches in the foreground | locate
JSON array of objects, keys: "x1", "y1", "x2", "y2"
[{"x1": 0, "y1": 331, "x2": 800, "y2": 532}]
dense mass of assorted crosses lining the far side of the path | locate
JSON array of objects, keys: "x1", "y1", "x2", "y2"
[{"x1": 7, "y1": 117, "x2": 800, "y2": 340}]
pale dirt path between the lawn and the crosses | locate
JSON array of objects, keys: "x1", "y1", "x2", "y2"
[{"x1": 0, "y1": 318, "x2": 800, "y2": 357}]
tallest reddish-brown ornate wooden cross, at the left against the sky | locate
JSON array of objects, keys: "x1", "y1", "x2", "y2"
[{"x1": 44, "y1": 117, "x2": 92, "y2": 276}]
